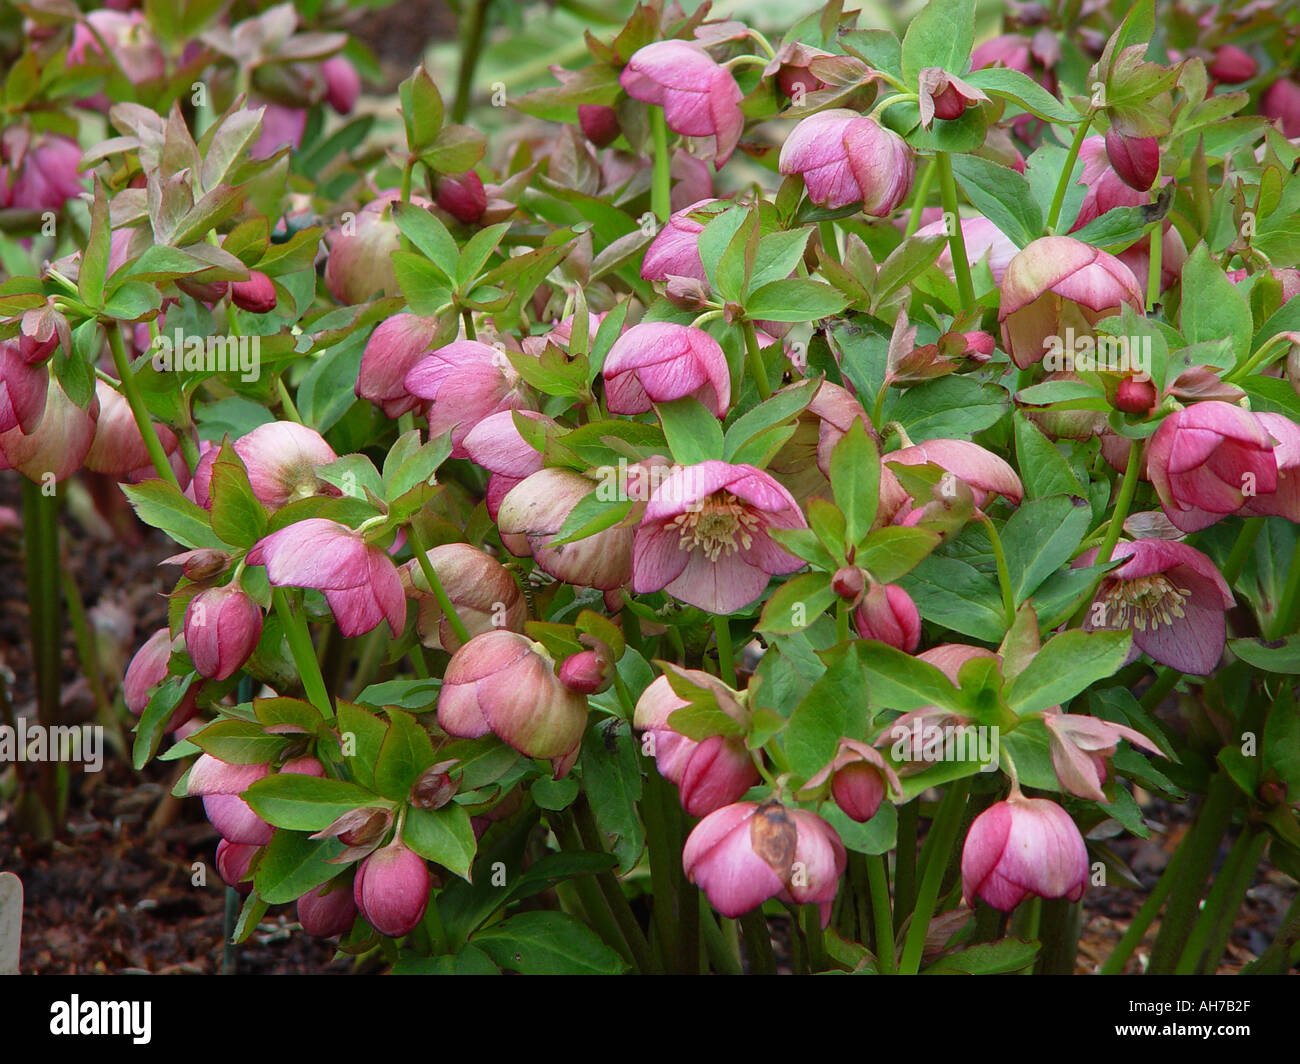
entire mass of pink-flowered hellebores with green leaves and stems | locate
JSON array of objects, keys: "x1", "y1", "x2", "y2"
[{"x1": 0, "y1": 0, "x2": 1300, "y2": 974}]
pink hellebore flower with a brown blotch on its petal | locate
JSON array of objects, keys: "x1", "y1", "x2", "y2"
[{"x1": 681, "y1": 801, "x2": 848, "y2": 926}]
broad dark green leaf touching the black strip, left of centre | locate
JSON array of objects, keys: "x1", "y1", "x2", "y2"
[{"x1": 473, "y1": 912, "x2": 627, "y2": 976}]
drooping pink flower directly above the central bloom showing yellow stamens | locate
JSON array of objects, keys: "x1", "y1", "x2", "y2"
[{"x1": 601, "y1": 321, "x2": 731, "y2": 418}]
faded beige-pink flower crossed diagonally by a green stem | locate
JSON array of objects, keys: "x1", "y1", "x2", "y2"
[{"x1": 399, "y1": 544, "x2": 528, "y2": 653}]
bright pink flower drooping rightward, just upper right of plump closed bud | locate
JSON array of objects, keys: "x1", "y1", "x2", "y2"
[{"x1": 246, "y1": 518, "x2": 406, "y2": 636}]
